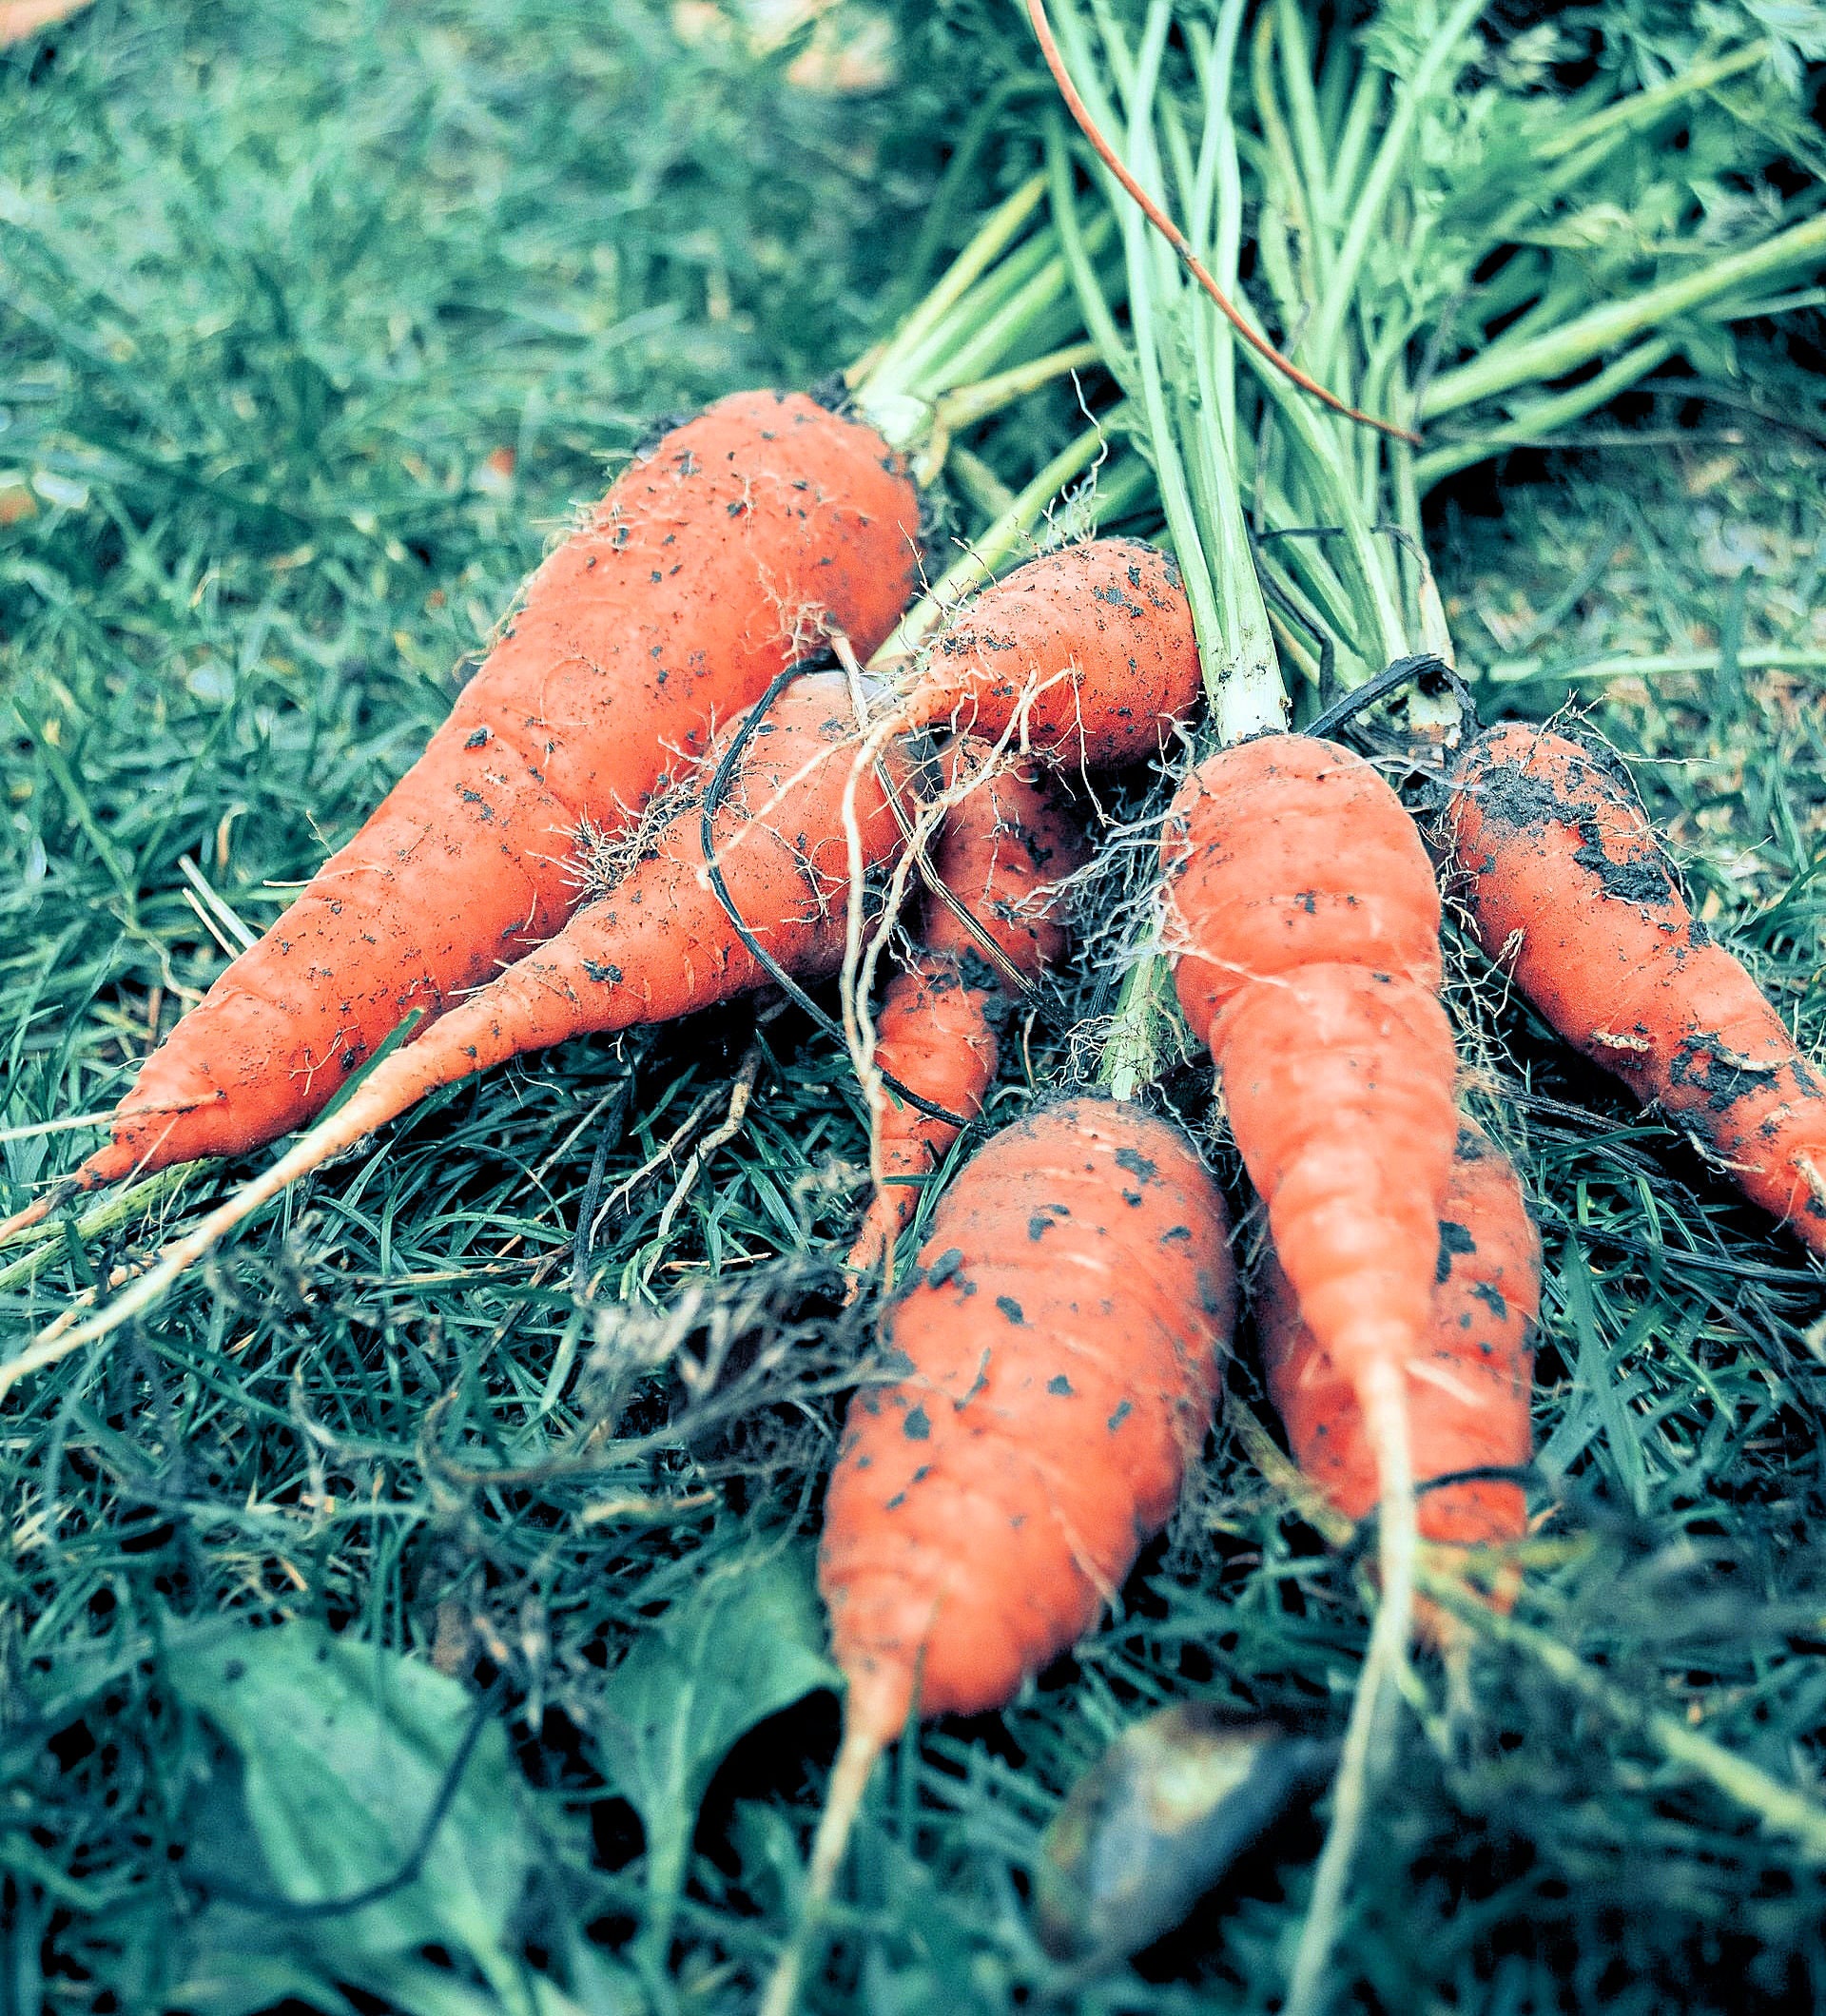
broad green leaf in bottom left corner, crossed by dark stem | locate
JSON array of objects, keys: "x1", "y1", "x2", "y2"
[{"x1": 167, "y1": 1623, "x2": 532, "y2": 1978}]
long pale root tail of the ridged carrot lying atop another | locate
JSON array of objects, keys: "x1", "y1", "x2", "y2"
[{"x1": 1282, "y1": 1359, "x2": 1419, "y2": 2016}]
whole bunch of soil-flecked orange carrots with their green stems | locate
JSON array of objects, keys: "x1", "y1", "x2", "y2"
[{"x1": 0, "y1": 0, "x2": 1826, "y2": 2016}]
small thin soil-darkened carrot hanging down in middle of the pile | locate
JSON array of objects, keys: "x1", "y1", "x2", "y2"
[{"x1": 850, "y1": 738, "x2": 1084, "y2": 1272}]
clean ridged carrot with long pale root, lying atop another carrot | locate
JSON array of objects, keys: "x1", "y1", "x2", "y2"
[{"x1": 1161, "y1": 734, "x2": 1457, "y2": 2010}]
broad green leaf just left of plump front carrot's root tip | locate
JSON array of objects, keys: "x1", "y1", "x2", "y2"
[{"x1": 596, "y1": 1548, "x2": 843, "y2": 1958}]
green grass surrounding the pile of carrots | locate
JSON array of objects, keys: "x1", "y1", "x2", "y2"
[{"x1": 10, "y1": 0, "x2": 1826, "y2": 2016}]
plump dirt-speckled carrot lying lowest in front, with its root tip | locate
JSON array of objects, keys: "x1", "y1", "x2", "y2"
[{"x1": 762, "y1": 1098, "x2": 1235, "y2": 2016}]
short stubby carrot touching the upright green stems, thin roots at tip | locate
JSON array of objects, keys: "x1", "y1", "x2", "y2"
[{"x1": 877, "y1": 538, "x2": 1201, "y2": 770}]
